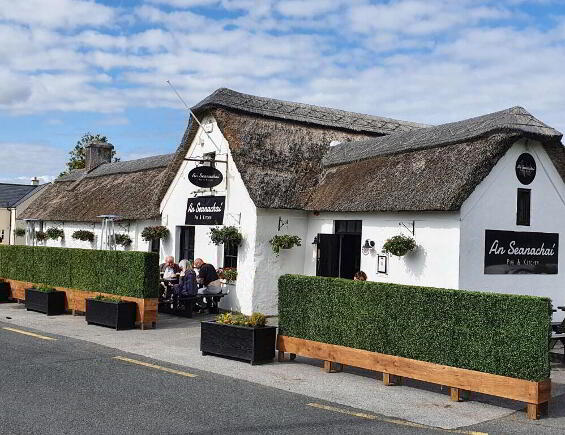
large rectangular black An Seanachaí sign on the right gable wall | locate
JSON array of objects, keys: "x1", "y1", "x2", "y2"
[{"x1": 485, "y1": 230, "x2": 559, "y2": 275}]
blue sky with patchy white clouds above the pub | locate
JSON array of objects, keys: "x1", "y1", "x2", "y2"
[{"x1": 0, "y1": 0, "x2": 565, "y2": 184}]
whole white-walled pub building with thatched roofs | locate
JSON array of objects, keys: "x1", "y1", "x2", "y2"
[{"x1": 20, "y1": 89, "x2": 565, "y2": 314}]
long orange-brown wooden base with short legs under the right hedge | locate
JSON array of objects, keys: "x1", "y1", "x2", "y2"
[{"x1": 277, "y1": 335, "x2": 551, "y2": 420}]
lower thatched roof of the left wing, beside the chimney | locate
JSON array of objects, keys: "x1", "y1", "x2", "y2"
[{"x1": 21, "y1": 154, "x2": 174, "y2": 222}]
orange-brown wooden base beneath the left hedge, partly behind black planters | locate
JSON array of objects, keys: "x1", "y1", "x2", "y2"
[{"x1": 4, "y1": 279, "x2": 159, "y2": 329}]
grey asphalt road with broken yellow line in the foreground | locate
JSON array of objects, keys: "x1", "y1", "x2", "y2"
[{"x1": 0, "y1": 322, "x2": 446, "y2": 435}]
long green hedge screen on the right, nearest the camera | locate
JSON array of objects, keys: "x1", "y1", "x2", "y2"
[{"x1": 279, "y1": 275, "x2": 551, "y2": 381}]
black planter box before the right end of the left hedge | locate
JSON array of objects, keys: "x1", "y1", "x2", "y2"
[{"x1": 86, "y1": 299, "x2": 137, "y2": 331}]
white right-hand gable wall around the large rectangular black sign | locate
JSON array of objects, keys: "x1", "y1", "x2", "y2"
[{"x1": 460, "y1": 139, "x2": 565, "y2": 318}]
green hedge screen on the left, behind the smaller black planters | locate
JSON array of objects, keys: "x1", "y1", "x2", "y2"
[{"x1": 0, "y1": 245, "x2": 159, "y2": 298}]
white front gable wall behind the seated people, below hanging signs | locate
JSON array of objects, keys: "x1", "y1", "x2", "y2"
[{"x1": 161, "y1": 117, "x2": 257, "y2": 313}]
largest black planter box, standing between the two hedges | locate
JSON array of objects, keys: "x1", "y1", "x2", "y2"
[{"x1": 200, "y1": 321, "x2": 277, "y2": 364}]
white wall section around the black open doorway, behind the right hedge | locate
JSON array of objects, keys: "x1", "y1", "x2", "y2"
[{"x1": 304, "y1": 213, "x2": 459, "y2": 288}]
